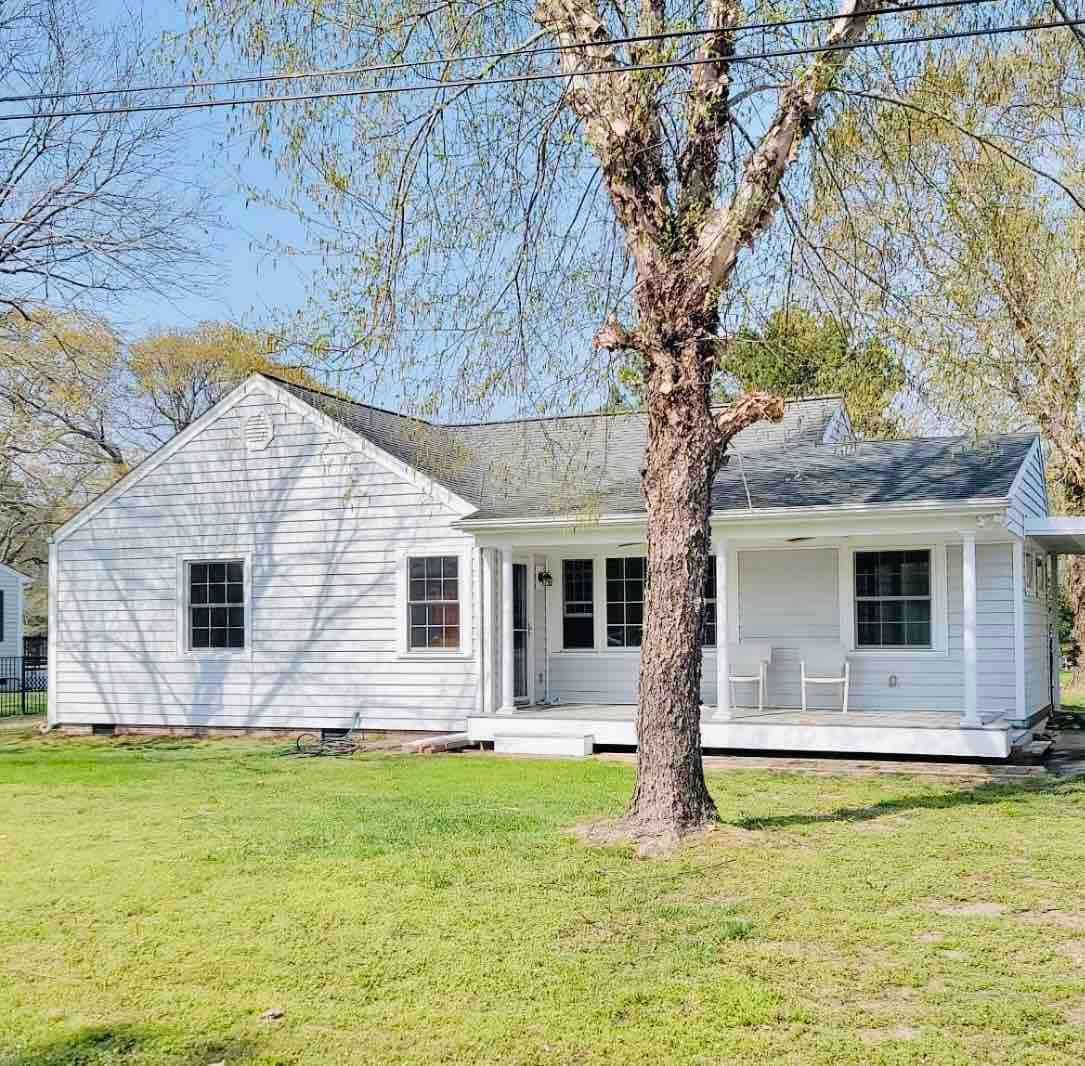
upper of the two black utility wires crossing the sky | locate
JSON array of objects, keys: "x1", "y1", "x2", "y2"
[{"x1": 0, "y1": 0, "x2": 993, "y2": 103}]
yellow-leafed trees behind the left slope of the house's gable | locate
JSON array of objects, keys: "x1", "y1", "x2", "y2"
[{"x1": 0, "y1": 307, "x2": 317, "y2": 610}]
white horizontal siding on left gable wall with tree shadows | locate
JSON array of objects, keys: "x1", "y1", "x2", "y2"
[{"x1": 53, "y1": 396, "x2": 477, "y2": 728}]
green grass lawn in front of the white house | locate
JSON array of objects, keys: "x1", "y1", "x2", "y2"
[{"x1": 0, "y1": 734, "x2": 1085, "y2": 1066}]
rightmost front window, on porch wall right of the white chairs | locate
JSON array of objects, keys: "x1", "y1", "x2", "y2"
[{"x1": 855, "y1": 548, "x2": 932, "y2": 648}]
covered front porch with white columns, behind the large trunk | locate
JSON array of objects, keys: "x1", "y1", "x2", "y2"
[{"x1": 468, "y1": 504, "x2": 1064, "y2": 759}]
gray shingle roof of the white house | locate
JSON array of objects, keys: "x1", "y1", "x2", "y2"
[{"x1": 264, "y1": 379, "x2": 1035, "y2": 519}]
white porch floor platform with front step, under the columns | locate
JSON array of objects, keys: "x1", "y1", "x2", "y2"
[{"x1": 468, "y1": 703, "x2": 1030, "y2": 759}]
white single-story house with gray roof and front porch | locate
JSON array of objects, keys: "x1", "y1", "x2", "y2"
[{"x1": 49, "y1": 375, "x2": 1085, "y2": 758}]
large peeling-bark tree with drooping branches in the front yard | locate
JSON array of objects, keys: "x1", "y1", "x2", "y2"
[{"x1": 182, "y1": 0, "x2": 1045, "y2": 851}]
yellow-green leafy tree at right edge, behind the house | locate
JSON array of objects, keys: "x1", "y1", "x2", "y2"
[{"x1": 819, "y1": 34, "x2": 1085, "y2": 684}]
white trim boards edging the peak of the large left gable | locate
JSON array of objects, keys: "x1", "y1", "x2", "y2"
[{"x1": 51, "y1": 373, "x2": 477, "y2": 544}]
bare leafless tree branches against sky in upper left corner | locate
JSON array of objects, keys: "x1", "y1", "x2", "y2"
[{"x1": 0, "y1": 0, "x2": 215, "y2": 312}]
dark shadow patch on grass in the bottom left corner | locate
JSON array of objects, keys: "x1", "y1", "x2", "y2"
[{"x1": 0, "y1": 1025, "x2": 256, "y2": 1066}]
